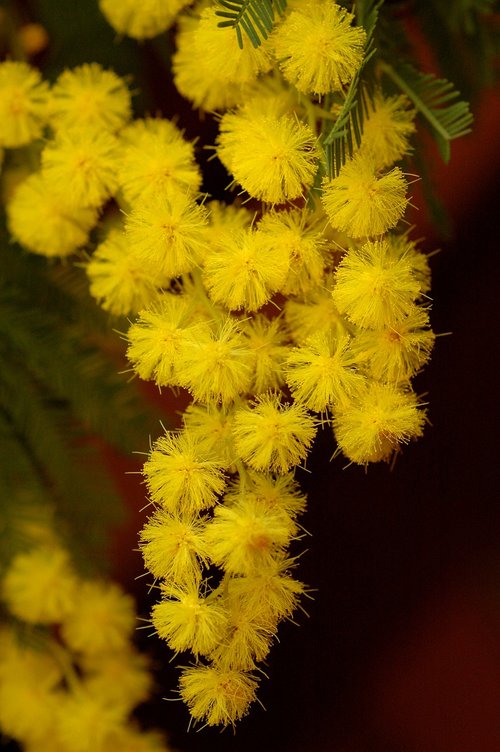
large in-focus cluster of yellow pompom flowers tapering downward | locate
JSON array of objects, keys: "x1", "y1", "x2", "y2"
[{"x1": 0, "y1": 0, "x2": 434, "y2": 725}]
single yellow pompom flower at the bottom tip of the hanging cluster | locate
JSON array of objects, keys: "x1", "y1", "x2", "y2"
[{"x1": 180, "y1": 665, "x2": 258, "y2": 726}]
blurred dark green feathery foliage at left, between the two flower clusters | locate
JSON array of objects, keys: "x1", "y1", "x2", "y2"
[{"x1": 0, "y1": 232, "x2": 159, "y2": 565}]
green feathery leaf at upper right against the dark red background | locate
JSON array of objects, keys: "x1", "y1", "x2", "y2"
[{"x1": 381, "y1": 62, "x2": 473, "y2": 162}]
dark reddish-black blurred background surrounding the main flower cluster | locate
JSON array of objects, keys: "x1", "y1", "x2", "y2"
[{"x1": 0, "y1": 0, "x2": 500, "y2": 752}]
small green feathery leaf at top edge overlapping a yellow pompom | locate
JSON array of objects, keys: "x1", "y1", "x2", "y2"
[{"x1": 215, "y1": 0, "x2": 286, "y2": 49}]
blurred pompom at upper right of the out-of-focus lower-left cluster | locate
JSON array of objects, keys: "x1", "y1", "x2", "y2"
[{"x1": 61, "y1": 580, "x2": 136, "y2": 655}]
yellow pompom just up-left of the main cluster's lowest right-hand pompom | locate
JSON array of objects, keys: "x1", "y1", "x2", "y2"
[{"x1": 285, "y1": 333, "x2": 364, "y2": 412}]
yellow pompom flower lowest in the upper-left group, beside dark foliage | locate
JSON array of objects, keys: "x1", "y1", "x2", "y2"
[{"x1": 6, "y1": 172, "x2": 97, "y2": 257}]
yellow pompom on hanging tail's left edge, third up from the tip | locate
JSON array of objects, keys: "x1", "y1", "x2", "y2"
[{"x1": 140, "y1": 509, "x2": 208, "y2": 585}]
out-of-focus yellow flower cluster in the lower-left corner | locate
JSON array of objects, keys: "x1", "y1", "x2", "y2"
[{"x1": 0, "y1": 541, "x2": 170, "y2": 752}]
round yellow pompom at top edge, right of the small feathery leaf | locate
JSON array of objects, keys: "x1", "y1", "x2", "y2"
[{"x1": 273, "y1": 0, "x2": 366, "y2": 96}]
